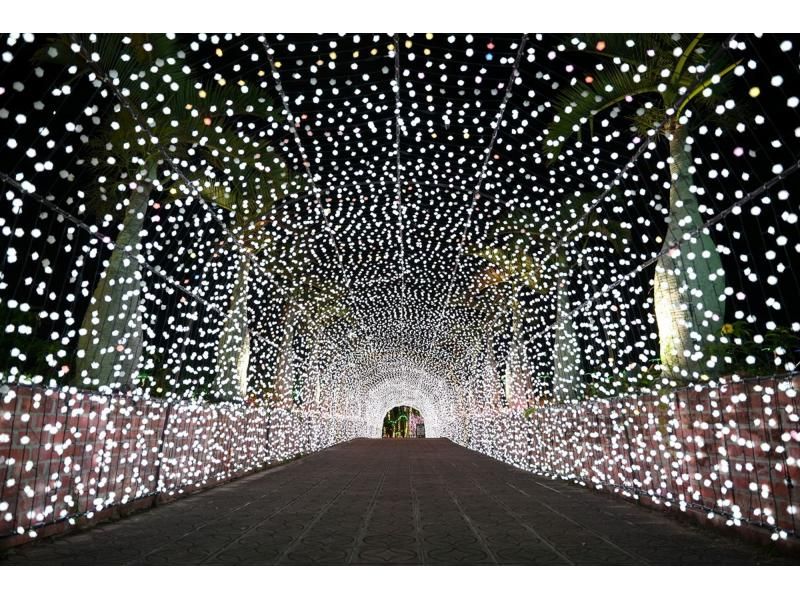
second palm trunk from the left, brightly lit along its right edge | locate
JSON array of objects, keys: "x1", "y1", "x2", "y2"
[{"x1": 214, "y1": 257, "x2": 252, "y2": 400}]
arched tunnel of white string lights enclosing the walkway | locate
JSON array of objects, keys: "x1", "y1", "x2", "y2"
[{"x1": 0, "y1": 33, "x2": 800, "y2": 552}]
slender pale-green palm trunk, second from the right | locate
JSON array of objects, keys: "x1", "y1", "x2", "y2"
[{"x1": 553, "y1": 268, "x2": 583, "y2": 401}]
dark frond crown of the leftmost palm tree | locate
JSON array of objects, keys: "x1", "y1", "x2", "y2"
[{"x1": 35, "y1": 33, "x2": 274, "y2": 165}]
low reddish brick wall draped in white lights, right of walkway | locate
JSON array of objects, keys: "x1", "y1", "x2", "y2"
[{"x1": 466, "y1": 377, "x2": 800, "y2": 540}]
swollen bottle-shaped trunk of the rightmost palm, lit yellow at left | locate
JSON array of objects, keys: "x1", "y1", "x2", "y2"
[{"x1": 654, "y1": 126, "x2": 725, "y2": 376}]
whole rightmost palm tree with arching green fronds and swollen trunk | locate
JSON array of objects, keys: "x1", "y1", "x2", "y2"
[{"x1": 543, "y1": 33, "x2": 738, "y2": 375}]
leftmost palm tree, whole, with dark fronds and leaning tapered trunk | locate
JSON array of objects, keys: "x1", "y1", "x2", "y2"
[{"x1": 37, "y1": 34, "x2": 286, "y2": 389}]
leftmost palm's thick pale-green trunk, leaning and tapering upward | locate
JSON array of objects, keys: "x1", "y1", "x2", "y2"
[{"x1": 76, "y1": 178, "x2": 155, "y2": 391}]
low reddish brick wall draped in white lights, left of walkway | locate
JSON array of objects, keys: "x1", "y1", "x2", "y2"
[{"x1": 0, "y1": 386, "x2": 364, "y2": 541}]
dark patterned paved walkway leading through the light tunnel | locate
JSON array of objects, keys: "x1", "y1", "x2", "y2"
[{"x1": 0, "y1": 439, "x2": 797, "y2": 565}]
